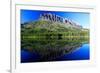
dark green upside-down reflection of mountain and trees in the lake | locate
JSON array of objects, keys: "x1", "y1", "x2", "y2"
[{"x1": 21, "y1": 34, "x2": 88, "y2": 61}]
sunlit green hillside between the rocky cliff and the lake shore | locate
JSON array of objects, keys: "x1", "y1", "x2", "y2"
[{"x1": 21, "y1": 21, "x2": 89, "y2": 36}]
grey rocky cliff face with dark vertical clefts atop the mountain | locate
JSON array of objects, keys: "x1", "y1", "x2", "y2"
[{"x1": 39, "y1": 13, "x2": 82, "y2": 29}]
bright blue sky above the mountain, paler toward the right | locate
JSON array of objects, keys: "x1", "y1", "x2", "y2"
[{"x1": 20, "y1": 10, "x2": 90, "y2": 28}]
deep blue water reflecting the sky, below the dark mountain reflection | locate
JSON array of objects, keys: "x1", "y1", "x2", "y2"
[{"x1": 21, "y1": 44, "x2": 90, "y2": 63}]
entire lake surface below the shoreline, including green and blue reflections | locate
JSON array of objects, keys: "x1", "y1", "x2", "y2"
[{"x1": 21, "y1": 37, "x2": 89, "y2": 63}]
